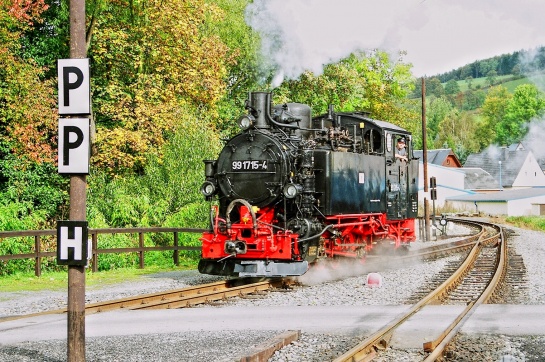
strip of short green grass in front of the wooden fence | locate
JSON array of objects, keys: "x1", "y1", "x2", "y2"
[{"x1": 0, "y1": 260, "x2": 196, "y2": 298}]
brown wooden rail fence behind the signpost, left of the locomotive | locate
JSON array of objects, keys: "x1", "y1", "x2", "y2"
[{"x1": 0, "y1": 227, "x2": 205, "y2": 277}]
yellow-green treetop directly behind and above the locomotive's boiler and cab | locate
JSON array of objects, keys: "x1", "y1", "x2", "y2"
[{"x1": 275, "y1": 51, "x2": 417, "y2": 132}]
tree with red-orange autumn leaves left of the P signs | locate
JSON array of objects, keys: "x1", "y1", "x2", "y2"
[{"x1": 0, "y1": 0, "x2": 67, "y2": 223}]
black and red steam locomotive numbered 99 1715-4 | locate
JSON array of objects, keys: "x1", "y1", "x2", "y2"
[{"x1": 198, "y1": 92, "x2": 418, "y2": 277}]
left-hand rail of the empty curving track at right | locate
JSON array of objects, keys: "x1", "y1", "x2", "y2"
[{"x1": 334, "y1": 220, "x2": 504, "y2": 362}]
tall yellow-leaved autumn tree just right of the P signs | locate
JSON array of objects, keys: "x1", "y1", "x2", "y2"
[{"x1": 89, "y1": 0, "x2": 232, "y2": 174}]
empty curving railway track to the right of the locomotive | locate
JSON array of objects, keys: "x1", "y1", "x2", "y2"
[{"x1": 334, "y1": 220, "x2": 507, "y2": 362}]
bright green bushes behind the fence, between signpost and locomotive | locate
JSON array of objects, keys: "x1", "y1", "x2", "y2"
[{"x1": 88, "y1": 107, "x2": 220, "y2": 269}]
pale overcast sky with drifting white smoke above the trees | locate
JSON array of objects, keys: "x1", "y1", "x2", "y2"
[{"x1": 246, "y1": 0, "x2": 545, "y2": 78}]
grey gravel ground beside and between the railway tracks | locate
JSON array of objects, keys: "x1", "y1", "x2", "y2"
[{"x1": 0, "y1": 222, "x2": 545, "y2": 362}]
